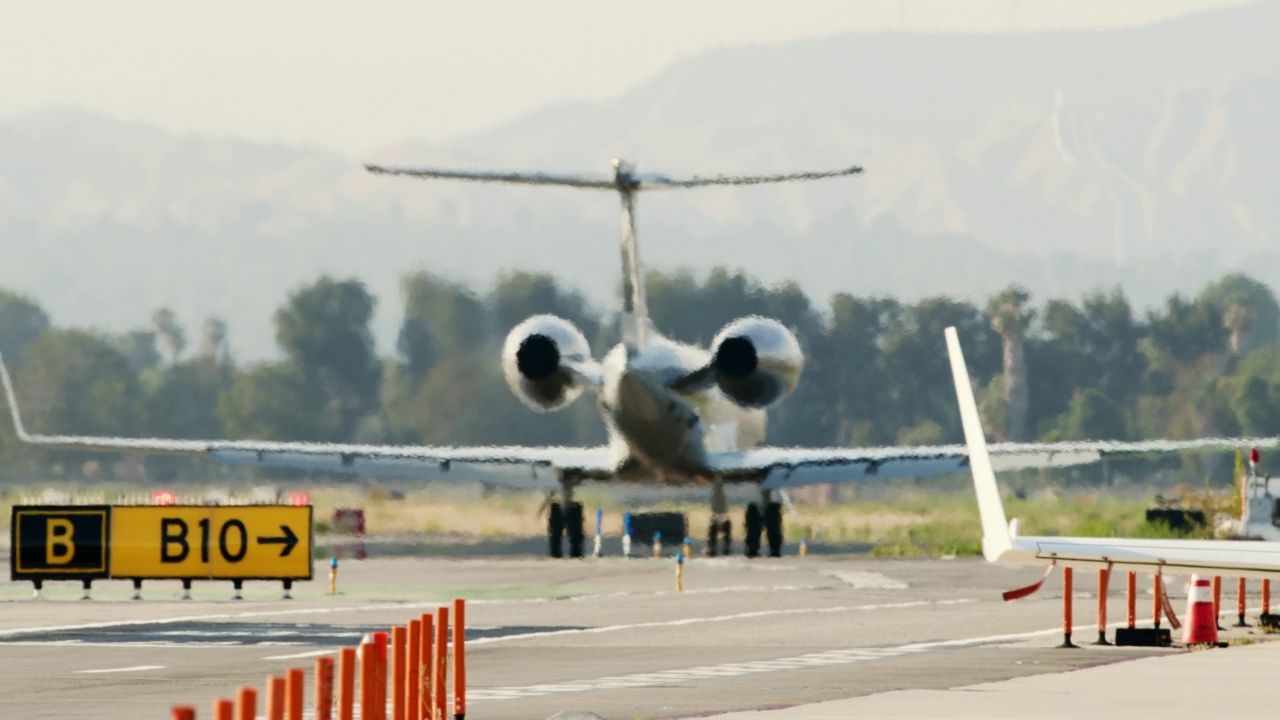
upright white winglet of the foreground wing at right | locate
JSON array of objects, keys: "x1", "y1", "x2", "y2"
[{"x1": 946, "y1": 328, "x2": 1012, "y2": 562}]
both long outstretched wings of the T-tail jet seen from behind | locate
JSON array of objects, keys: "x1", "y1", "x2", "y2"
[{"x1": 0, "y1": 351, "x2": 1276, "y2": 489}]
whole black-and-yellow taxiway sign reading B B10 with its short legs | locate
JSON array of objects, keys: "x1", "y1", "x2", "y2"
[{"x1": 10, "y1": 505, "x2": 312, "y2": 600}]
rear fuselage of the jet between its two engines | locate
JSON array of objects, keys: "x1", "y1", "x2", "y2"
[{"x1": 599, "y1": 329, "x2": 765, "y2": 482}]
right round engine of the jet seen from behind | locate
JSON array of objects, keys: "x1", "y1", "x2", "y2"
[{"x1": 712, "y1": 315, "x2": 804, "y2": 409}]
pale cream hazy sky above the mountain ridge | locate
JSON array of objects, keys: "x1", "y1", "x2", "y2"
[{"x1": 0, "y1": 0, "x2": 1238, "y2": 158}]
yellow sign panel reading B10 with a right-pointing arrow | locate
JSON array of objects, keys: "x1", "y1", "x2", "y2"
[{"x1": 110, "y1": 505, "x2": 311, "y2": 580}]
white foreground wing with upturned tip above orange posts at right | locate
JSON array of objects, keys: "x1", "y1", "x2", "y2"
[{"x1": 946, "y1": 328, "x2": 1280, "y2": 578}]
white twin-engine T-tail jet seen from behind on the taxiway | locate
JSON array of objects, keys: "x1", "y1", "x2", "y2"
[{"x1": 0, "y1": 160, "x2": 1274, "y2": 557}]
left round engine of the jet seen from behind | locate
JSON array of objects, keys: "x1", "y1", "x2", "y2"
[{"x1": 502, "y1": 315, "x2": 591, "y2": 413}]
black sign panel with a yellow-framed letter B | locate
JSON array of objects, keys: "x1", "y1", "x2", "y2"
[{"x1": 9, "y1": 505, "x2": 111, "y2": 580}]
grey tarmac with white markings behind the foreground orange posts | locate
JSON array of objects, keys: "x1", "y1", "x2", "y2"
[{"x1": 0, "y1": 556, "x2": 1259, "y2": 719}]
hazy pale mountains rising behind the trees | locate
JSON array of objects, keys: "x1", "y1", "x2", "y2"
[{"x1": 0, "y1": 3, "x2": 1280, "y2": 359}]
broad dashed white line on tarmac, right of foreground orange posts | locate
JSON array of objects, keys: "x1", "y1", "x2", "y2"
[{"x1": 467, "y1": 609, "x2": 1162, "y2": 702}]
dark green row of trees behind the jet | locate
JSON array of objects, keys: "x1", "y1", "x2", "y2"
[{"x1": 0, "y1": 268, "x2": 1280, "y2": 478}]
